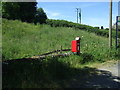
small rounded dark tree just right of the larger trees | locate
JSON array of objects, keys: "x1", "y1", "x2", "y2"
[{"x1": 34, "y1": 8, "x2": 47, "y2": 24}]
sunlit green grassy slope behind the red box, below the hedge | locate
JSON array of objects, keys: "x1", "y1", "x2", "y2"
[{"x1": 2, "y1": 19, "x2": 119, "y2": 60}]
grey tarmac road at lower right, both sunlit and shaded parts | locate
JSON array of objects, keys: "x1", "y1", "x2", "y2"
[{"x1": 86, "y1": 62, "x2": 120, "y2": 88}]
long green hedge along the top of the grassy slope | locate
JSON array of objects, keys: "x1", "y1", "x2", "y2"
[{"x1": 46, "y1": 19, "x2": 120, "y2": 38}]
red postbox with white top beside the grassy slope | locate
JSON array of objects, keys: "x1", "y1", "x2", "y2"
[{"x1": 71, "y1": 37, "x2": 80, "y2": 53}]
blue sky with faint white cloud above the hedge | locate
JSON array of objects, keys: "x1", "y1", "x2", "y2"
[{"x1": 37, "y1": 2, "x2": 118, "y2": 28}]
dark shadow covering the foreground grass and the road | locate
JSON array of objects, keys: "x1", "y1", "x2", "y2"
[{"x1": 2, "y1": 57, "x2": 120, "y2": 88}]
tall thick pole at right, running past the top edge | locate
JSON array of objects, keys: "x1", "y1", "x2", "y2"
[{"x1": 109, "y1": 0, "x2": 112, "y2": 49}]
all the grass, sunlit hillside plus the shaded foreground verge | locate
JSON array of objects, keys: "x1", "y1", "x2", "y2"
[{"x1": 2, "y1": 19, "x2": 120, "y2": 88}]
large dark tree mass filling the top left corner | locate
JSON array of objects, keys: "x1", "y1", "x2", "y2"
[{"x1": 2, "y1": 2, "x2": 37, "y2": 22}]
